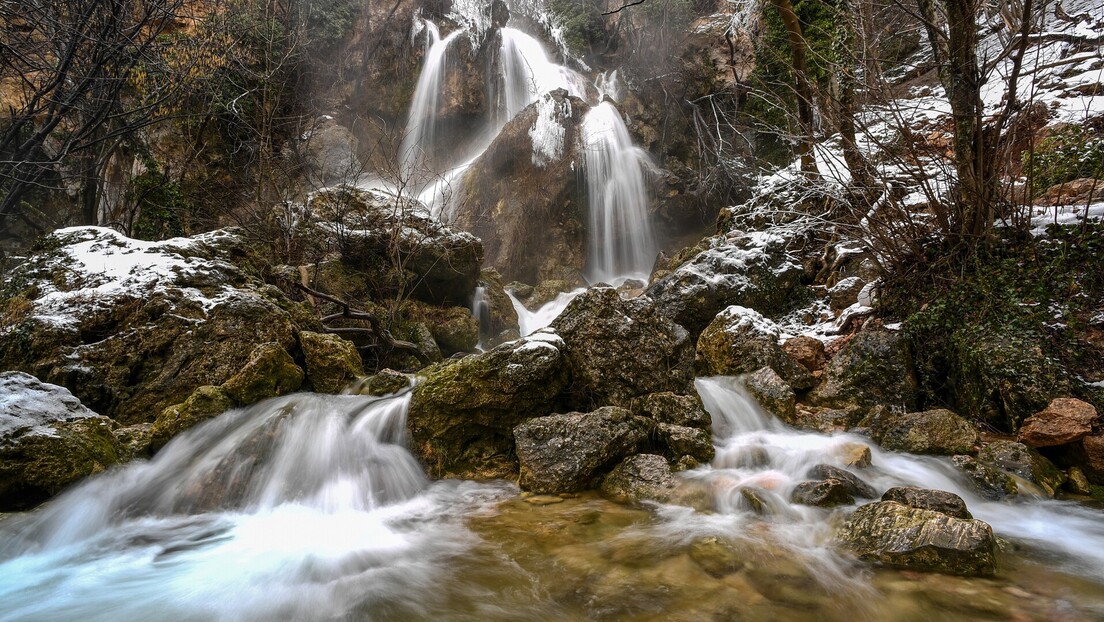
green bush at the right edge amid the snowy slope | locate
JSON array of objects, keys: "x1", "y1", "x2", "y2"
[{"x1": 1023, "y1": 125, "x2": 1104, "y2": 194}]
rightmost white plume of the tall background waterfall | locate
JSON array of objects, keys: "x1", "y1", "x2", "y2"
[{"x1": 583, "y1": 102, "x2": 656, "y2": 283}]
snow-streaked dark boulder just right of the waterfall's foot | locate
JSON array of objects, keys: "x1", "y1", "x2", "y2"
[{"x1": 647, "y1": 234, "x2": 803, "y2": 340}]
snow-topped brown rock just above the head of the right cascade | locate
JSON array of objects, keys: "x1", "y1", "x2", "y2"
[{"x1": 694, "y1": 306, "x2": 813, "y2": 389}]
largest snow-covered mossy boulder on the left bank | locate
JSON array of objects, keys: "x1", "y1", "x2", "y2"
[{"x1": 0, "y1": 226, "x2": 317, "y2": 424}]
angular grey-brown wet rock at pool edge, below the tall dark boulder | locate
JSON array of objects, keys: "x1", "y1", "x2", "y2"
[{"x1": 513, "y1": 407, "x2": 649, "y2": 494}]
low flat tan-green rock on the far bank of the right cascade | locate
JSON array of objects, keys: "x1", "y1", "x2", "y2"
[{"x1": 871, "y1": 409, "x2": 981, "y2": 455}]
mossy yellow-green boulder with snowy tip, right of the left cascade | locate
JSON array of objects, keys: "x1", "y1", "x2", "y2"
[{"x1": 408, "y1": 330, "x2": 567, "y2": 477}]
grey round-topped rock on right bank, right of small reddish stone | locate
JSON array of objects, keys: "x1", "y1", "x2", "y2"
[{"x1": 809, "y1": 329, "x2": 916, "y2": 409}]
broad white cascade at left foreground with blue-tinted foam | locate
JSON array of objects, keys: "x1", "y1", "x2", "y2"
[{"x1": 0, "y1": 394, "x2": 516, "y2": 621}]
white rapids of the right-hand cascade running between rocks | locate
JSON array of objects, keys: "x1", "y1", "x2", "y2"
[{"x1": 684, "y1": 378, "x2": 1104, "y2": 581}]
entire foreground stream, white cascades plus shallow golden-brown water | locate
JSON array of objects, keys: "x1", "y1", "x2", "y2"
[{"x1": 0, "y1": 378, "x2": 1104, "y2": 621}]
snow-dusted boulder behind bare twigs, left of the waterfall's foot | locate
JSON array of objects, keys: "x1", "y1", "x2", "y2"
[{"x1": 309, "y1": 187, "x2": 484, "y2": 306}]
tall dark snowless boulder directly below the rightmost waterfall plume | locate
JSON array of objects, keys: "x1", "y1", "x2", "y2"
[{"x1": 552, "y1": 287, "x2": 693, "y2": 410}]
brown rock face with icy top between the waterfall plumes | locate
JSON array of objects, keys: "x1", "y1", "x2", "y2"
[{"x1": 453, "y1": 92, "x2": 587, "y2": 283}]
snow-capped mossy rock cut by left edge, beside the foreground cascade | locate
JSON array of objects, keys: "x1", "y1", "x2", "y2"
[{"x1": 0, "y1": 371, "x2": 124, "y2": 512}]
